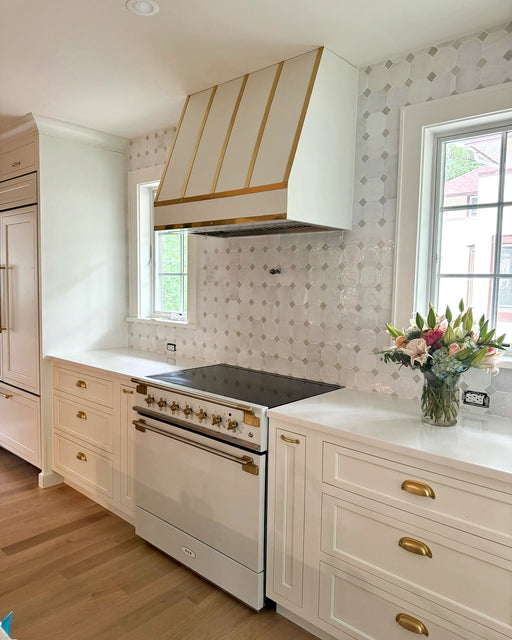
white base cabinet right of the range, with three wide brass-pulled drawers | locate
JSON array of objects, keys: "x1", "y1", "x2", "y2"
[{"x1": 267, "y1": 418, "x2": 512, "y2": 640}]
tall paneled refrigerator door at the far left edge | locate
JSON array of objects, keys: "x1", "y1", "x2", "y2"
[{"x1": 0, "y1": 207, "x2": 39, "y2": 393}]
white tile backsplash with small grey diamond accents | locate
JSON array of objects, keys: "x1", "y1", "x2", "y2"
[{"x1": 129, "y1": 23, "x2": 512, "y2": 417}]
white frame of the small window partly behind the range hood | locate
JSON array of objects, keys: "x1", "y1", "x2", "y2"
[{"x1": 127, "y1": 166, "x2": 197, "y2": 326}]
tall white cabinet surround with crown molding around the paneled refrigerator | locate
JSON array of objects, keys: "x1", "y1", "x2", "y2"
[{"x1": 0, "y1": 114, "x2": 128, "y2": 486}]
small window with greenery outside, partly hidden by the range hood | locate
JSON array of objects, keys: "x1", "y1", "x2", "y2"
[{"x1": 128, "y1": 167, "x2": 195, "y2": 324}]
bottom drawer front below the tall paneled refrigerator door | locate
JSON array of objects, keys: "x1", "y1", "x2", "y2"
[{"x1": 0, "y1": 386, "x2": 41, "y2": 468}]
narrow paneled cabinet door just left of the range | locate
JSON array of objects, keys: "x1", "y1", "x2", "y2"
[{"x1": 120, "y1": 385, "x2": 137, "y2": 515}]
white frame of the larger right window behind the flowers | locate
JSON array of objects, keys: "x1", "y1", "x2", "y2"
[{"x1": 392, "y1": 84, "x2": 512, "y2": 367}]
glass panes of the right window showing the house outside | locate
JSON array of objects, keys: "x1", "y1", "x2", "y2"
[{"x1": 431, "y1": 126, "x2": 512, "y2": 342}]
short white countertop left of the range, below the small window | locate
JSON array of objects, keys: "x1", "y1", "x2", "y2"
[{"x1": 49, "y1": 347, "x2": 212, "y2": 378}]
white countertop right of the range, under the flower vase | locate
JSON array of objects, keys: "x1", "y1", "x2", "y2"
[{"x1": 268, "y1": 389, "x2": 512, "y2": 482}]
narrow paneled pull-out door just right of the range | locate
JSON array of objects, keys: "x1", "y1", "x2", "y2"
[{"x1": 269, "y1": 429, "x2": 306, "y2": 607}]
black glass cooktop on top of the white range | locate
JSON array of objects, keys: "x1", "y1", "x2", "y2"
[{"x1": 149, "y1": 364, "x2": 341, "y2": 409}]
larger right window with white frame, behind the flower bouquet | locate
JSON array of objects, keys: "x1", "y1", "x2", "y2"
[{"x1": 393, "y1": 84, "x2": 512, "y2": 362}]
